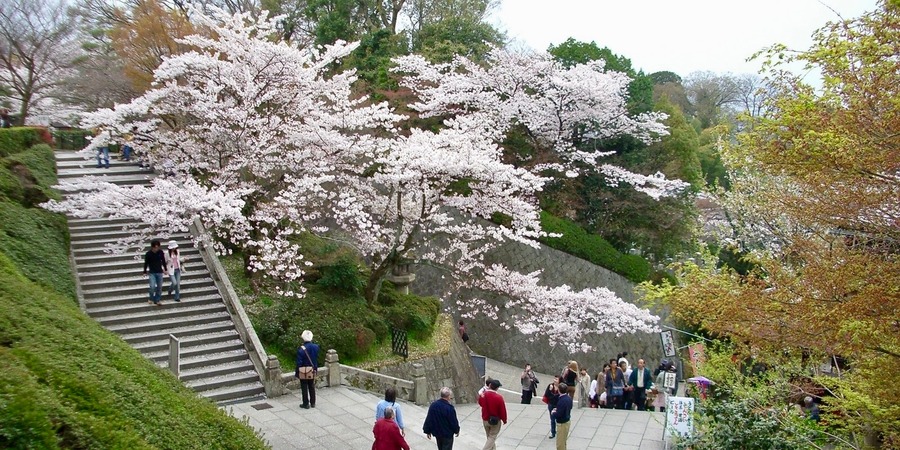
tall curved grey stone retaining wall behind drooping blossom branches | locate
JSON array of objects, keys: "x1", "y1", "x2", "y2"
[{"x1": 410, "y1": 242, "x2": 662, "y2": 375}]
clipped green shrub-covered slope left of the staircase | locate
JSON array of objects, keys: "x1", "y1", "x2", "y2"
[{"x1": 0, "y1": 139, "x2": 265, "y2": 449}]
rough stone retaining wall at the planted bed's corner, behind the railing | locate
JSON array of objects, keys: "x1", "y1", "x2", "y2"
[{"x1": 373, "y1": 324, "x2": 482, "y2": 404}]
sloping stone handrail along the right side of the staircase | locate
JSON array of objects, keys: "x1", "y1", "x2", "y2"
[{"x1": 191, "y1": 218, "x2": 284, "y2": 397}]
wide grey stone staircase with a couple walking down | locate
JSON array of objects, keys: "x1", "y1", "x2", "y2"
[{"x1": 56, "y1": 151, "x2": 264, "y2": 402}]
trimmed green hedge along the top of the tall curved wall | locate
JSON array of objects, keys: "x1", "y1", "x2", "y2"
[{"x1": 541, "y1": 212, "x2": 653, "y2": 283}]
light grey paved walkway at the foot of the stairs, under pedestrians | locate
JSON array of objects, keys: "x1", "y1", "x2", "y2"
[{"x1": 224, "y1": 360, "x2": 665, "y2": 450}]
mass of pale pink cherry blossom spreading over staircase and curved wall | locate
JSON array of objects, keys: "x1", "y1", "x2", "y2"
[{"x1": 48, "y1": 7, "x2": 679, "y2": 351}]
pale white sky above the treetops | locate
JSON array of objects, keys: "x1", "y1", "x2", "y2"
[{"x1": 493, "y1": 0, "x2": 877, "y2": 77}]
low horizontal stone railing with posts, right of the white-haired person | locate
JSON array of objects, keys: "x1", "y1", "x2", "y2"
[{"x1": 281, "y1": 349, "x2": 428, "y2": 406}]
